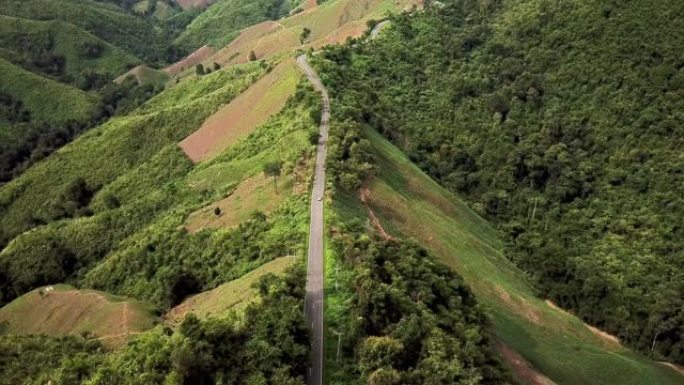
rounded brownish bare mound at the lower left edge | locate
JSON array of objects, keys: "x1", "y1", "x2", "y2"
[{"x1": 0, "y1": 285, "x2": 155, "y2": 347}]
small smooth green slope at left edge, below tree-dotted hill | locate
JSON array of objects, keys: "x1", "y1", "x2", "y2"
[{"x1": 0, "y1": 59, "x2": 96, "y2": 123}]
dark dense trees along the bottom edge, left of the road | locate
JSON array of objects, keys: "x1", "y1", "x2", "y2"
[{"x1": 0, "y1": 265, "x2": 309, "y2": 385}]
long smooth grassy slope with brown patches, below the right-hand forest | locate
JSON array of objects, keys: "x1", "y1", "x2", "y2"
[{"x1": 340, "y1": 132, "x2": 683, "y2": 385}]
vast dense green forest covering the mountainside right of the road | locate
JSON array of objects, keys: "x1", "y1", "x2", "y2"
[{"x1": 318, "y1": 0, "x2": 684, "y2": 363}]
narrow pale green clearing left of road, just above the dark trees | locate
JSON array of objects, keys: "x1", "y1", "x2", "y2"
[{"x1": 164, "y1": 256, "x2": 296, "y2": 324}]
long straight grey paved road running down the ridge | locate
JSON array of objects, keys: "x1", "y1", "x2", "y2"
[{"x1": 297, "y1": 55, "x2": 330, "y2": 385}]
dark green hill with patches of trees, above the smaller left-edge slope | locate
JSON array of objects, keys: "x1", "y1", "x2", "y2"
[{"x1": 0, "y1": 15, "x2": 139, "y2": 89}]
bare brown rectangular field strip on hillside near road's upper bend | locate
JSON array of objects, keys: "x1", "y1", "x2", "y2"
[{"x1": 180, "y1": 59, "x2": 300, "y2": 163}]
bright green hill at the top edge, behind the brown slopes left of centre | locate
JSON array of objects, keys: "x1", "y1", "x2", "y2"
[{"x1": 175, "y1": 0, "x2": 292, "y2": 49}]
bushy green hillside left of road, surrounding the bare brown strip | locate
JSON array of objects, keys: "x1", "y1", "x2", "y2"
[{"x1": 0, "y1": 60, "x2": 312, "y2": 309}]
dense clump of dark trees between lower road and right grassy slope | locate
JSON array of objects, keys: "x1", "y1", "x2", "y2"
[{"x1": 328, "y1": 216, "x2": 512, "y2": 385}]
